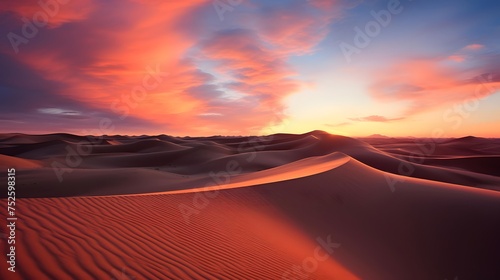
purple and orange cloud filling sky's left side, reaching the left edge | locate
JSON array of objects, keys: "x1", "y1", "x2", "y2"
[{"x1": 0, "y1": 0, "x2": 217, "y2": 135}]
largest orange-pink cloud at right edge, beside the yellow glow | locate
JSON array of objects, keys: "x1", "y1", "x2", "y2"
[{"x1": 371, "y1": 60, "x2": 500, "y2": 116}]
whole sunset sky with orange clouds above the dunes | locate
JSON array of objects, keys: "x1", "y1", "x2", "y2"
[{"x1": 0, "y1": 0, "x2": 500, "y2": 137}]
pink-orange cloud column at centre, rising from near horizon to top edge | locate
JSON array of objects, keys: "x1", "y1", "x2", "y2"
[{"x1": 188, "y1": 3, "x2": 348, "y2": 133}]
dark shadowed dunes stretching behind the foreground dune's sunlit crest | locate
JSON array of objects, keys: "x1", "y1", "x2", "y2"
[{"x1": 0, "y1": 131, "x2": 500, "y2": 197}]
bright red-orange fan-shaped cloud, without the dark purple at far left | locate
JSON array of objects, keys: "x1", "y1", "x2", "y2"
[{"x1": 5, "y1": 0, "x2": 213, "y2": 133}]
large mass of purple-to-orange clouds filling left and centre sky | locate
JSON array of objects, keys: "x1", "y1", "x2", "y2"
[{"x1": 0, "y1": 0, "x2": 350, "y2": 135}]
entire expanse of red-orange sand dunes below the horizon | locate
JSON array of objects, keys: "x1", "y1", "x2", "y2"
[{"x1": 0, "y1": 131, "x2": 500, "y2": 280}]
